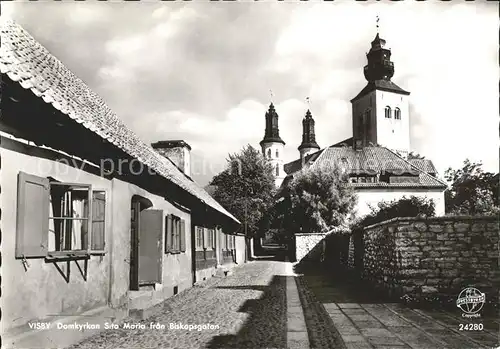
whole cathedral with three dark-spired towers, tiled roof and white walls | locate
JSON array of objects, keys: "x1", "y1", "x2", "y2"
[{"x1": 261, "y1": 33, "x2": 447, "y2": 215}]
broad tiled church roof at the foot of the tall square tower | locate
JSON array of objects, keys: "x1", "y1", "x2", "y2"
[{"x1": 284, "y1": 146, "x2": 446, "y2": 189}]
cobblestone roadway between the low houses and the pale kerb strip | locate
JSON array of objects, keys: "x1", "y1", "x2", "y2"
[{"x1": 71, "y1": 253, "x2": 289, "y2": 349}]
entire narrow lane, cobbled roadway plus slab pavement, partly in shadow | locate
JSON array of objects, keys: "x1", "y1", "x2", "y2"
[{"x1": 70, "y1": 245, "x2": 499, "y2": 349}]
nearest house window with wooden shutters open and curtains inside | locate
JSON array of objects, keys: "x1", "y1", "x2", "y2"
[{"x1": 15, "y1": 172, "x2": 106, "y2": 258}]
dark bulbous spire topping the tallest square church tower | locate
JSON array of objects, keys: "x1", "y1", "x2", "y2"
[{"x1": 364, "y1": 16, "x2": 394, "y2": 82}]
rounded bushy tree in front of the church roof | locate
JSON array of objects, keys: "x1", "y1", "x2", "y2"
[{"x1": 276, "y1": 163, "x2": 357, "y2": 233}]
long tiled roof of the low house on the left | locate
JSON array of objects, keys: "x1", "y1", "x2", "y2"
[{"x1": 0, "y1": 20, "x2": 240, "y2": 223}]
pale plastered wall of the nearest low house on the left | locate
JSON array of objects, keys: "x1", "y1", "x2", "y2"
[{"x1": 0, "y1": 139, "x2": 192, "y2": 330}]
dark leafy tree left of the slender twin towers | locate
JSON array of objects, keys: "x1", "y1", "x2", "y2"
[{"x1": 210, "y1": 145, "x2": 275, "y2": 237}]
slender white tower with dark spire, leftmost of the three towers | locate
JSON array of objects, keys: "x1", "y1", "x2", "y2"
[{"x1": 260, "y1": 103, "x2": 286, "y2": 187}]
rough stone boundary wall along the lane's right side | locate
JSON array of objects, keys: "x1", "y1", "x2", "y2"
[{"x1": 356, "y1": 216, "x2": 500, "y2": 303}]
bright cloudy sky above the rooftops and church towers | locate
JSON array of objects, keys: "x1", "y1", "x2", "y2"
[{"x1": 2, "y1": 0, "x2": 500, "y2": 185}]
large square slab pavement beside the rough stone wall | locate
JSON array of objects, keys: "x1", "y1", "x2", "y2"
[{"x1": 299, "y1": 270, "x2": 500, "y2": 349}]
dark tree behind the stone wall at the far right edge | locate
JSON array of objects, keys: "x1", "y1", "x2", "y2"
[{"x1": 445, "y1": 159, "x2": 499, "y2": 215}]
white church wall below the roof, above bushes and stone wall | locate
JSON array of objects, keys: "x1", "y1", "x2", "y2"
[{"x1": 356, "y1": 189, "x2": 445, "y2": 216}]
